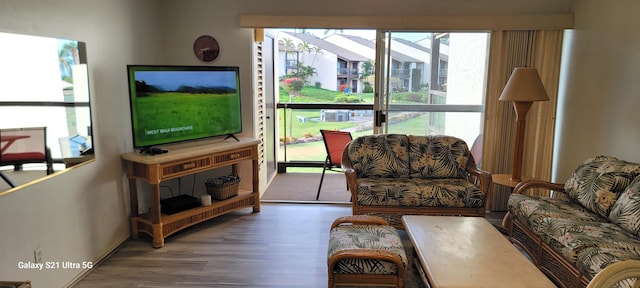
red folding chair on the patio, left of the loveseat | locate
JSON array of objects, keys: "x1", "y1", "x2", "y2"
[{"x1": 316, "y1": 130, "x2": 353, "y2": 200}]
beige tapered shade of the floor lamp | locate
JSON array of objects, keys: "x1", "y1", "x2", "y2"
[{"x1": 499, "y1": 67, "x2": 549, "y2": 102}]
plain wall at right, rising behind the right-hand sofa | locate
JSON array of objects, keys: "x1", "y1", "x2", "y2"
[{"x1": 553, "y1": 0, "x2": 640, "y2": 183}]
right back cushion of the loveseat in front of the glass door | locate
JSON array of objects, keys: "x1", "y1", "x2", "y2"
[{"x1": 409, "y1": 136, "x2": 471, "y2": 179}]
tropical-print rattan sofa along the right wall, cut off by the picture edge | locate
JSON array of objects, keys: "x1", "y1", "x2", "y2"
[{"x1": 504, "y1": 156, "x2": 640, "y2": 287}]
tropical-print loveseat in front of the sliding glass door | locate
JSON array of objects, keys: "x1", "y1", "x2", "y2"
[{"x1": 342, "y1": 134, "x2": 491, "y2": 229}]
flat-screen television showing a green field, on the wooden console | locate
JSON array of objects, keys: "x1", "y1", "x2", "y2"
[{"x1": 127, "y1": 65, "x2": 242, "y2": 148}]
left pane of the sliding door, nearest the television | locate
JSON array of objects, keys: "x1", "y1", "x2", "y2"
[{"x1": 274, "y1": 29, "x2": 376, "y2": 173}]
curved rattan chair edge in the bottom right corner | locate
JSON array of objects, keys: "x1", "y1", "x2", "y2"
[{"x1": 587, "y1": 260, "x2": 640, "y2": 288}]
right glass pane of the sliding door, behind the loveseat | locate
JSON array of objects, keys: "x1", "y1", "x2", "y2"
[{"x1": 374, "y1": 31, "x2": 489, "y2": 145}]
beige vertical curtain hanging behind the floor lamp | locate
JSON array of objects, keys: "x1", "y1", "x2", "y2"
[{"x1": 482, "y1": 30, "x2": 563, "y2": 211}]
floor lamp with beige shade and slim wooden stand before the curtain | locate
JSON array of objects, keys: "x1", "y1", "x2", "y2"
[{"x1": 499, "y1": 67, "x2": 549, "y2": 182}]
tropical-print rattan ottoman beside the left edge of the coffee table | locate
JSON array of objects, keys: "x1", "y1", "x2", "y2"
[{"x1": 327, "y1": 215, "x2": 407, "y2": 288}]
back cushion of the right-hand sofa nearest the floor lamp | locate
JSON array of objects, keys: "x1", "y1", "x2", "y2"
[{"x1": 564, "y1": 156, "x2": 640, "y2": 218}]
